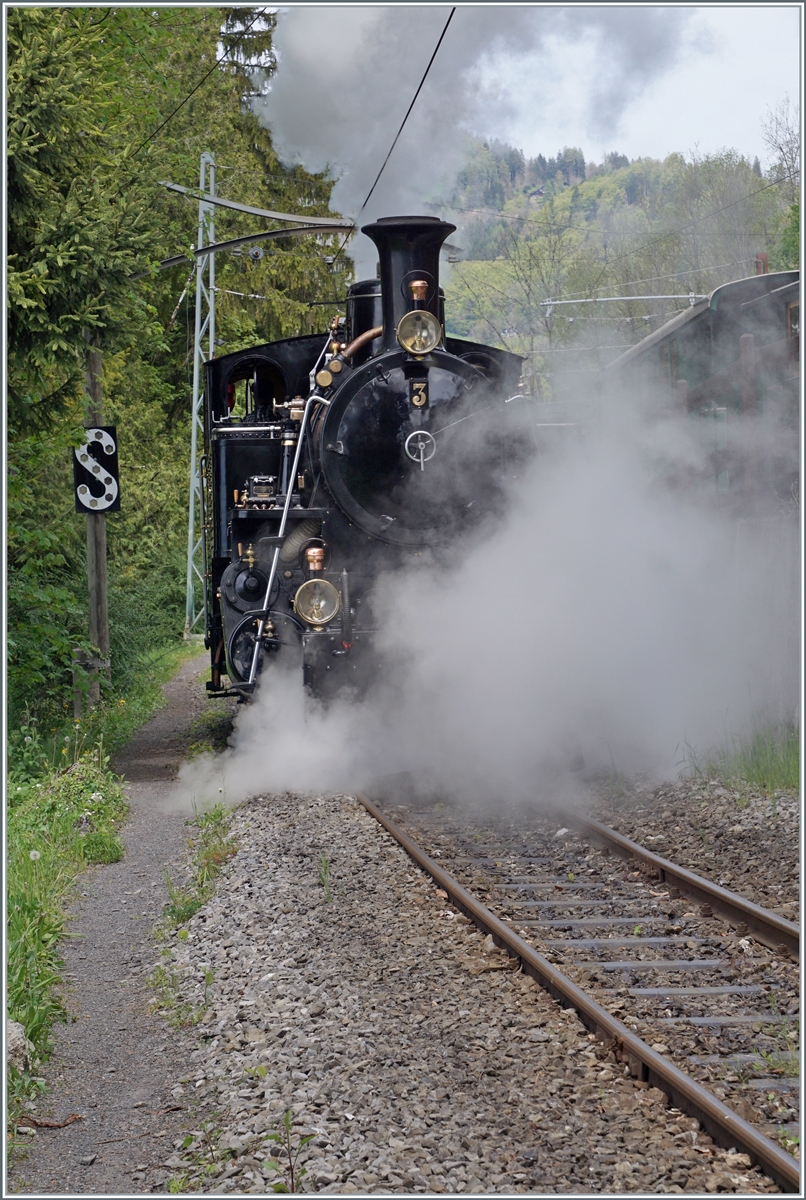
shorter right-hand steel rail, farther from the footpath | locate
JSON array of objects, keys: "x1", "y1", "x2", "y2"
[{"x1": 566, "y1": 812, "x2": 800, "y2": 959}]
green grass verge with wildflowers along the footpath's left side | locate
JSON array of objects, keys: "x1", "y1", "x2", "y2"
[{"x1": 6, "y1": 643, "x2": 206, "y2": 1124}]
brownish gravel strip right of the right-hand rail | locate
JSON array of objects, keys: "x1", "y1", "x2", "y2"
[{"x1": 588, "y1": 780, "x2": 801, "y2": 922}]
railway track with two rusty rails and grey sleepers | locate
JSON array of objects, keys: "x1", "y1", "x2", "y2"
[{"x1": 360, "y1": 792, "x2": 800, "y2": 1193}]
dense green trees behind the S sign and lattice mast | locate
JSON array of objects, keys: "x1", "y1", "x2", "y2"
[{"x1": 7, "y1": 6, "x2": 345, "y2": 742}]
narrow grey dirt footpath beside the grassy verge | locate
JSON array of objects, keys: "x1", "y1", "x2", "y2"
[{"x1": 6, "y1": 656, "x2": 210, "y2": 1195}]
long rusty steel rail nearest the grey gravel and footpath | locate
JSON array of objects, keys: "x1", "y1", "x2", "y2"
[{"x1": 356, "y1": 792, "x2": 800, "y2": 1195}]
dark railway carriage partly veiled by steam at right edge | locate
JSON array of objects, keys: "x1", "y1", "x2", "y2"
[{"x1": 599, "y1": 271, "x2": 800, "y2": 515}]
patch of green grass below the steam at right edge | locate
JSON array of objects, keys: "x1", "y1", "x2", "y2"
[{"x1": 684, "y1": 724, "x2": 800, "y2": 793}]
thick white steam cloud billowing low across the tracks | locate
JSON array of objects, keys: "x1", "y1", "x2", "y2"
[{"x1": 172, "y1": 391, "x2": 800, "y2": 803}]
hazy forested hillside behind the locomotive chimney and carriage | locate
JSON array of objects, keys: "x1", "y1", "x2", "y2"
[{"x1": 446, "y1": 135, "x2": 799, "y2": 398}]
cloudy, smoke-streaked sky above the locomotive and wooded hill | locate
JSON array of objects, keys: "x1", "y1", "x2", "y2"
[{"x1": 260, "y1": 4, "x2": 801, "y2": 236}]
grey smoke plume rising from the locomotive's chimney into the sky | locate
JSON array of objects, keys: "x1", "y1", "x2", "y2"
[{"x1": 258, "y1": 5, "x2": 692, "y2": 277}]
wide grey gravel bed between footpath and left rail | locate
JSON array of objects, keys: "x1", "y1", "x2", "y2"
[{"x1": 152, "y1": 796, "x2": 778, "y2": 1194}]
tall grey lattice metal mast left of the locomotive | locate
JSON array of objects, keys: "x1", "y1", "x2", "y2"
[{"x1": 185, "y1": 151, "x2": 216, "y2": 638}]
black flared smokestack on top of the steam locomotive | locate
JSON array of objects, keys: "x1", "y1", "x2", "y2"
[{"x1": 361, "y1": 217, "x2": 456, "y2": 350}]
